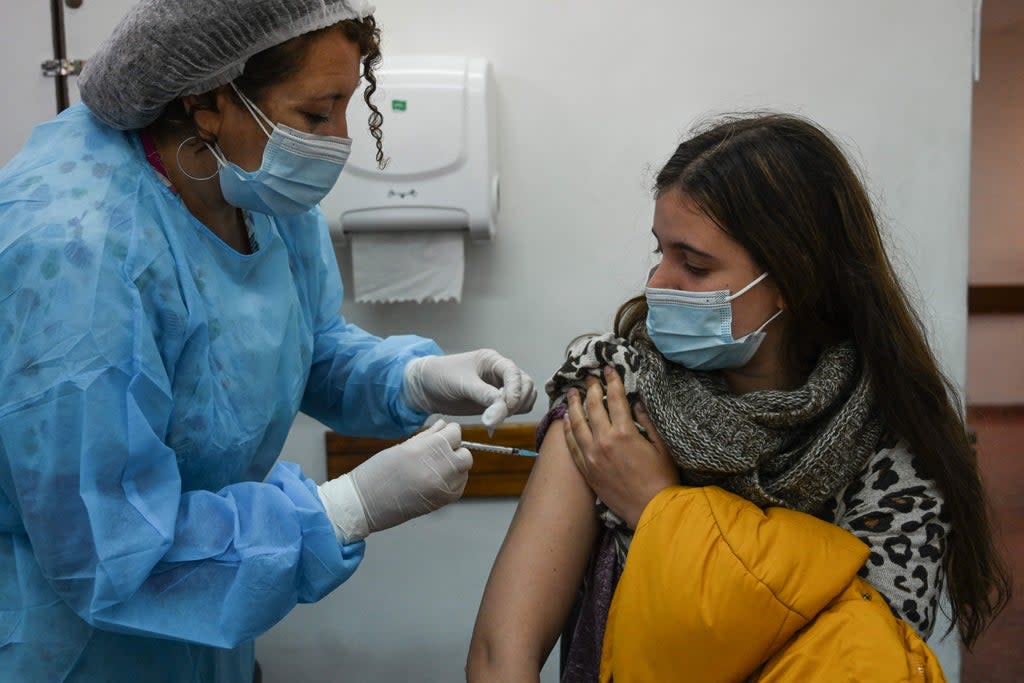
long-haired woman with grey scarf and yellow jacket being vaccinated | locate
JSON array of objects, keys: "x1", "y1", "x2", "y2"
[{"x1": 467, "y1": 115, "x2": 1009, "y2": 683}]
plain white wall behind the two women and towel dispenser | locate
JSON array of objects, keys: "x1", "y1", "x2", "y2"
[{"x1": 258, "y1": 0, "x2": 973, "y2": 682}]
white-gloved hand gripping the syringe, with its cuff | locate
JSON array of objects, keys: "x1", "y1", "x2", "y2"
[{"x1": 317, "y1": 420, "x2": 473, "y2": 543}]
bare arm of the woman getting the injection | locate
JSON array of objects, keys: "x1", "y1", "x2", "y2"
[{"x1": 468, "y1": 422, "x2": 598, "y2": 681}]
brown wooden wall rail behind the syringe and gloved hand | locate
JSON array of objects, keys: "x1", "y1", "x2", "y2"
[{"x1": 326, "y1": 424, "x2": 537, "y2": 498}]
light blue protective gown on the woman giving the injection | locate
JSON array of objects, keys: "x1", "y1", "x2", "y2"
[{"x1": 0, "y1": 105, "x2": 440, "y2": 683}]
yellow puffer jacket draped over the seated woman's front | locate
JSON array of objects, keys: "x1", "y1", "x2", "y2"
[{"x1": 600, "y1": 486, "x2": 945, "y2": 683}]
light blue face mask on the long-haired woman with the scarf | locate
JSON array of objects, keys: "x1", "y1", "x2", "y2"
[{"x1": 646, "y1": 272, "x2": 782, "y2": 370}]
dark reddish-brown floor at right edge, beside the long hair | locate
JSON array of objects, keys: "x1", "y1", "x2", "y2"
[{"x1": 961, "y1": 408, "x2": 1024, "y2": 683}]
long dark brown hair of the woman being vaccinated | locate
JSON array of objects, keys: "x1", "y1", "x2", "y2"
[{"x1": 615, "y1": 114, "x2": 1011, "y2": 648}]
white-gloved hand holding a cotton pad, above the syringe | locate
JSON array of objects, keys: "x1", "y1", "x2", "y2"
[{"x1": 401, "y1": 348, "x2": 537, "y2": 429}]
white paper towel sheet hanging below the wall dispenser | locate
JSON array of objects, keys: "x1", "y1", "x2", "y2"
[{"x1": 349, "y1": 231, "x2": 465, "y2": 303}]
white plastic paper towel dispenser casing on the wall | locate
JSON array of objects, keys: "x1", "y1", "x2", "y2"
[{"x1": 321, "y1": 56, "x2": 499, "y2": 242}]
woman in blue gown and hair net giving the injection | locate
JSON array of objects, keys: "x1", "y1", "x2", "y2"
[{"x1": 0, "y1": 0, "x2": 536, "y2": 683}]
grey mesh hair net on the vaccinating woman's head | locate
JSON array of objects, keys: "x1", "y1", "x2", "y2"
[{"x1": 79, "y1": 0, "x2": 374, "y2": 130}]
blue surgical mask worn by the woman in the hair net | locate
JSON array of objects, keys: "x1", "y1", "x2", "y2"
[{"x1": 210, "y1": 83, "x2": 352, "y2": 216}]
